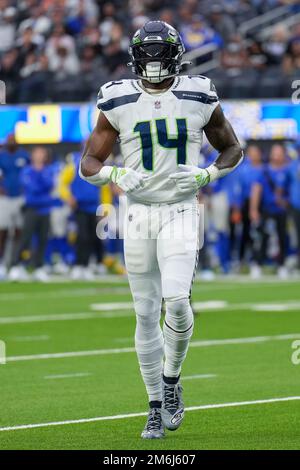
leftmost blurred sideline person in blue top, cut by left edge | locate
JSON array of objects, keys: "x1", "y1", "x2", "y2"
[{"x1": 0, "y1": 134, "x2": 29, "y2": 278}]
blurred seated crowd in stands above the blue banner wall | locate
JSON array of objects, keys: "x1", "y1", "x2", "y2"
[{"x1": 0, "y1": 0, "x2": 300, "y2": 103}]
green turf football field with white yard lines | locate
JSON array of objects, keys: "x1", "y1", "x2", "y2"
[{"x1": 0, "y1": 280, "x2": 300, "y2": 450}]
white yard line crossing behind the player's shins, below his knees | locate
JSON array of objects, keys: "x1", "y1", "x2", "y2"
[{"x1": 6, "y1": 333, "x2": 300, "y2": 362}]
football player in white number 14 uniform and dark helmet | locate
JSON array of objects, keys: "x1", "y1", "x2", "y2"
[{"x1": 80, "y1": 21, "x2": 243, "y2": 439}]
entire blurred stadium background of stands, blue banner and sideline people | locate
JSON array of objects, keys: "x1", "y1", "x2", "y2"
[{"x1": 0, "y1": 0, "x2": 300, "y2": 282}]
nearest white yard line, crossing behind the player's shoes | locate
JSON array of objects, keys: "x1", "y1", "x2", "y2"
[{"x1": 0, "y1": 396, "x2": 300, "y2": 432}]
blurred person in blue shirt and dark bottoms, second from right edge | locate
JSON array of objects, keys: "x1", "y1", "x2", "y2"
[{"x1": 250, "y1": 144, "x2": 288, "y2": 278}]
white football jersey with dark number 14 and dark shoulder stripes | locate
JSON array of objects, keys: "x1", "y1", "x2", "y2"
[{"x1": 97, "y1": 75, "x2": 218, "y2": 204}]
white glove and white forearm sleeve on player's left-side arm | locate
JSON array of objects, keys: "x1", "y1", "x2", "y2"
[{"x1": 79, "y1": 166, "x2": 147, "y2": 193}]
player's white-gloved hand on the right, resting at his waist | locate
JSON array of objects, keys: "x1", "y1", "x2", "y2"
[{"x1": 169, "y1": 165, "x2": 210, "y2": 192}]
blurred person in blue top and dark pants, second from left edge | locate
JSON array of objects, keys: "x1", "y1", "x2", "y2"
[{"x1": 9, "y1": 147, "x2": 54, "y2": 282}]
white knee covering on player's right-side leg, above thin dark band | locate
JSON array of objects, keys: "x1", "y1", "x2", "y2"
[{"x1": 165, "y1": 297, "x2": 194, "y2": 334}]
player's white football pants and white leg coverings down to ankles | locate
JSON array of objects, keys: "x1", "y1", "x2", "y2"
[{"x1": 124, "y1": 198, "x2": 199, "y2": 401}]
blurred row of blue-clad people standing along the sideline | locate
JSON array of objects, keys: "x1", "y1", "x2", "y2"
[{"x1": 0, "y1": 135, "x2": 300, "y2": 281}]
